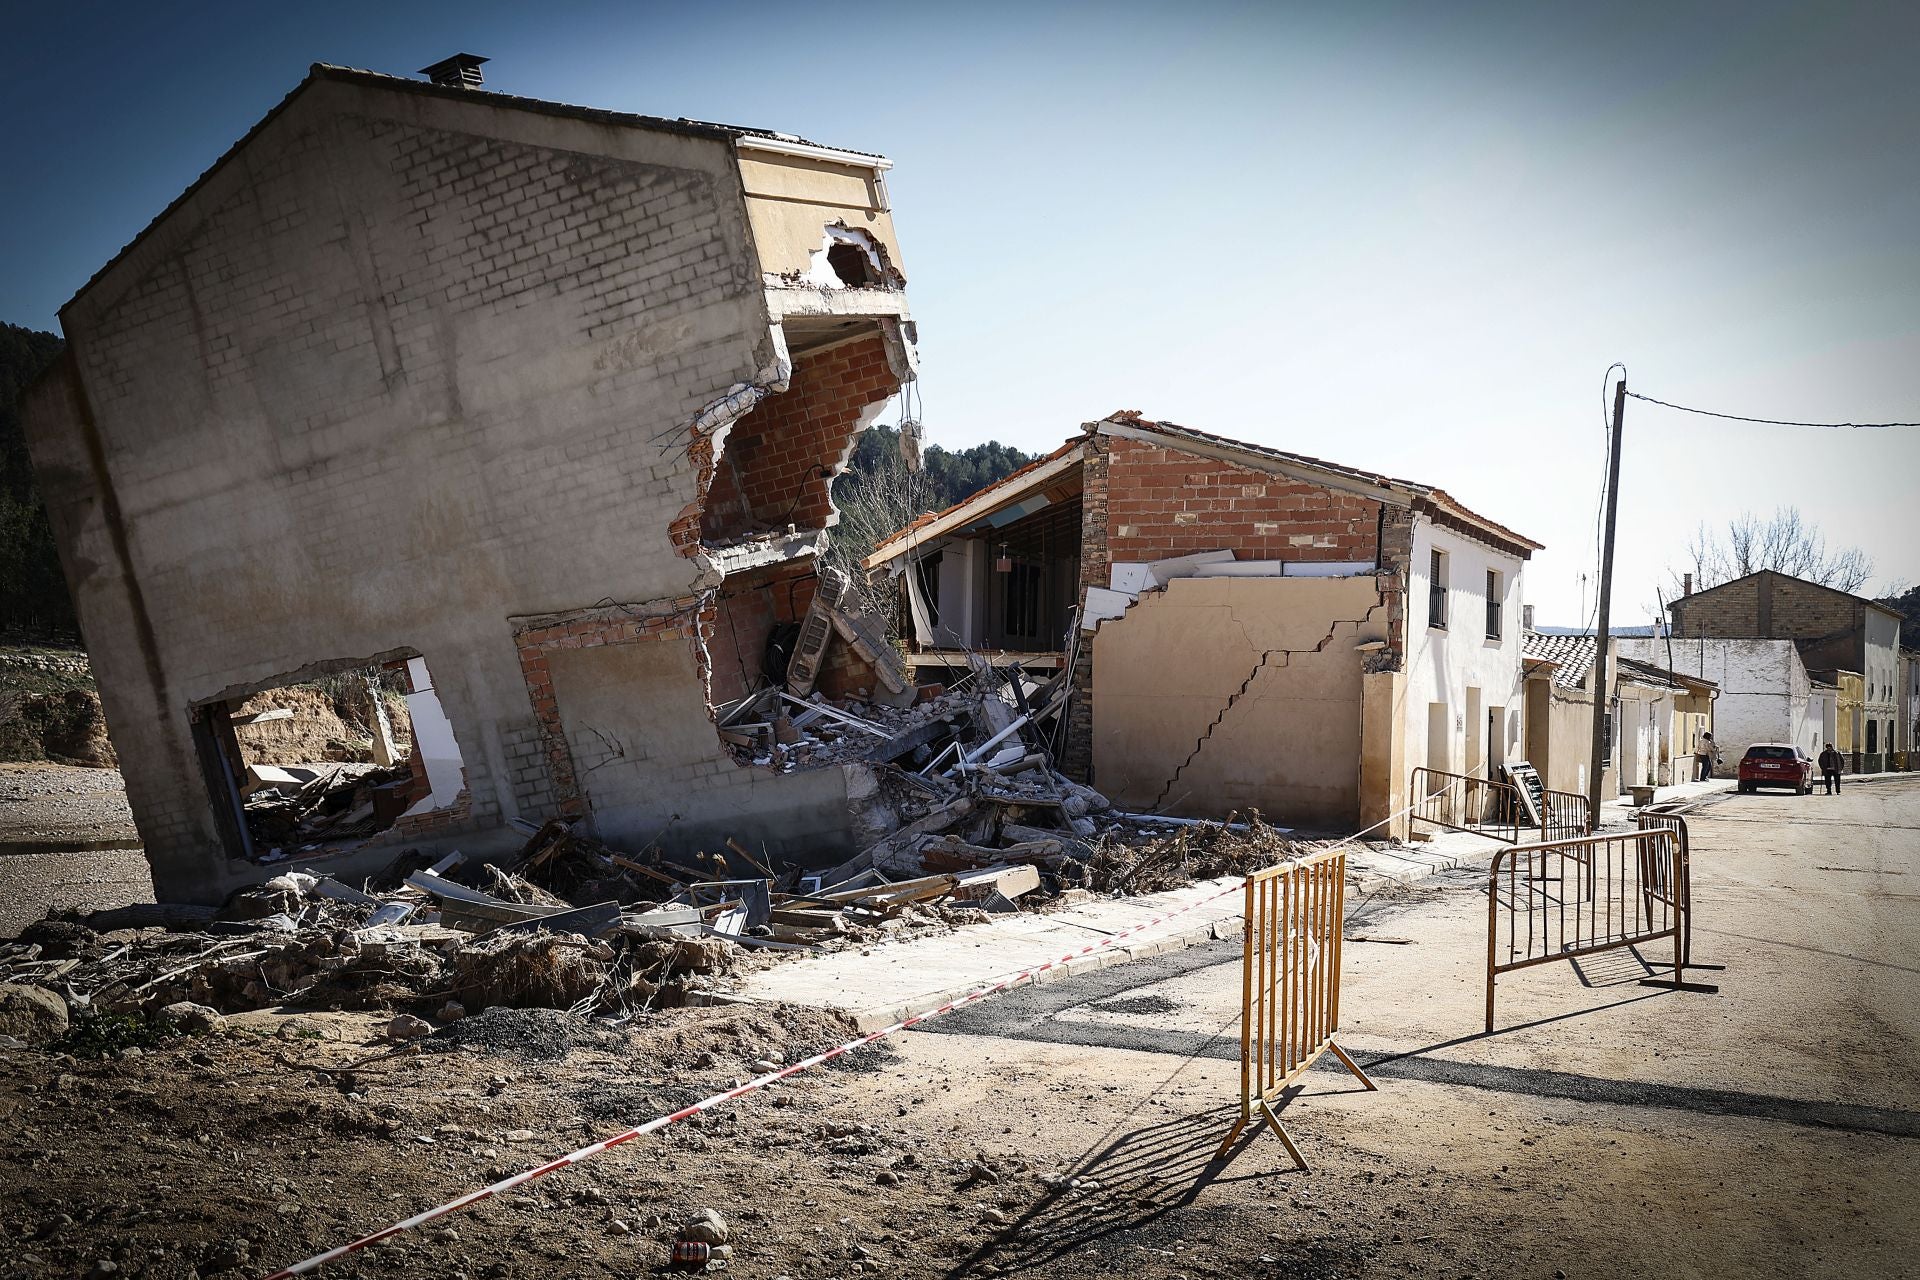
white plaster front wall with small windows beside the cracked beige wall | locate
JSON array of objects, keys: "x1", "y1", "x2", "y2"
[{"x1": 1400, "y1": 516, "x2": 1526, "y2": 773}]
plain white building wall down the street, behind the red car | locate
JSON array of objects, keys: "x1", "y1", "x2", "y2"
[{"x1": 1615, "y1": 637, "x2": 1820, "y2": 777}]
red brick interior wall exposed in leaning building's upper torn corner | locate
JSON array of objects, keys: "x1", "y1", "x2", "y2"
[{"x1": 701, "y1": 334, "x2": 900, "y2": 541}]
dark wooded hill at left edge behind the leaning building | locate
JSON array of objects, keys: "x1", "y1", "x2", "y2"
[{"x1": 0, "y1": 324, "x2": 77, "y2": 633}]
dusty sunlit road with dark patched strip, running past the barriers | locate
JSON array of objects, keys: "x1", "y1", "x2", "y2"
[{"x1": 856, "y1": 779, "x2": 1920, "y2": 1278}]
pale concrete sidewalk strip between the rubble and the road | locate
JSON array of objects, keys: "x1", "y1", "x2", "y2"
[{"x1": 732, "y1": 831, "x2": 1507, "y2": 1031}]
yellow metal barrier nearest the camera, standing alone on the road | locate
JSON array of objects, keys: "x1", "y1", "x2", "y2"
[{"x1": 1219, "y1": 850, "x2": 1375, "y2": 1169}]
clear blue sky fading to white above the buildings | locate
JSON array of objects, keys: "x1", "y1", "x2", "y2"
[{"x1": 0, "y1": 0, "x2": 1920, "y2": 622}]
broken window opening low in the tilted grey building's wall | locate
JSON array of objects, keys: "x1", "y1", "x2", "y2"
[{"x1": 192, "y1": 652, "x2": 467, "y2": 862}]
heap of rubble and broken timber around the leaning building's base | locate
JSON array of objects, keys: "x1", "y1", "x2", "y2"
[{"x1": 0, "y1": 664, "x2": 1294, "y2": 1044}]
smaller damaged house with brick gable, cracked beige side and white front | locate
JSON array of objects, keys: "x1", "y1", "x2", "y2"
[{"x1": 868, "y1": 413, "x2": 1540, "y2": 835}]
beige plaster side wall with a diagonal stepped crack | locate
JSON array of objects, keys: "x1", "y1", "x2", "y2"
[{"x1": 1092, "y1": 576, "x2": 1386, "y2": 827}]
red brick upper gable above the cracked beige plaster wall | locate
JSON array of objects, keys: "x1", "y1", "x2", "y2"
[{"x1": 1100, "y1": 438, "x2": 1380, "y2": 564}]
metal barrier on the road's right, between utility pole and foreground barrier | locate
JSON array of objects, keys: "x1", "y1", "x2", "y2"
[{"x1": 1486, "y1": 814, "x2": 1718, "y2": 1031}]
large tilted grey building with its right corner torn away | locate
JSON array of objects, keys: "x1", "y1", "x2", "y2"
[{"x1": 25, "y1": 65, "x2": 914, "y2": 902}]
